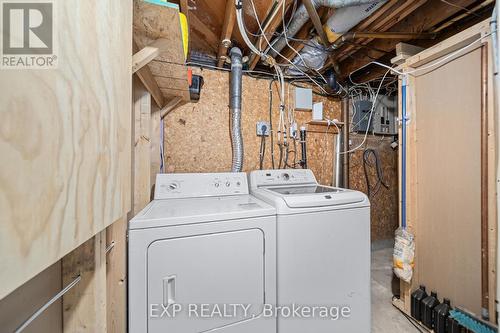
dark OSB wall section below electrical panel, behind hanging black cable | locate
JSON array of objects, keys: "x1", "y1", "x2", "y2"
[{"x1": 349, "y1": 134, "x2": 399, "y2": 241}]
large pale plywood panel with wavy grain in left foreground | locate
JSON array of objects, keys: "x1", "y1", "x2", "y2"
[{"x1": 0, "y1": 0, "x2": 132, "y2": 299}]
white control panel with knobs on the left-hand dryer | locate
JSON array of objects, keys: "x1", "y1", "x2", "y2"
[{"x1": 155, "y1": 172, "x2": 248, "y2": 200}]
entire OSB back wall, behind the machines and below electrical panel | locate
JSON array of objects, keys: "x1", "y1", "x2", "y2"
[{"x1": 165, "y1": 69, "x2": 398, "y2": 240}]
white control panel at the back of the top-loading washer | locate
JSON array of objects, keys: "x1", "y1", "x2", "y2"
[{"x1": 249, "y1": 169, "x2": 317, "y2": 188}]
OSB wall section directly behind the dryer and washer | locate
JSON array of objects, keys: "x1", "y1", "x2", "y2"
[{"x1": 165, "y1": 69, "x2": 340, "y2": 184}]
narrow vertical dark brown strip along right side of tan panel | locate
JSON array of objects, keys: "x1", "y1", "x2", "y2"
[{"x1": 481, "y1": 45, "x2": 489, "y2": 320}]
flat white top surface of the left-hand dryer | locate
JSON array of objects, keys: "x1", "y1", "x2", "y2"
[{"x1": 129, "y1": 195, "x2": 276, "y2": 229}]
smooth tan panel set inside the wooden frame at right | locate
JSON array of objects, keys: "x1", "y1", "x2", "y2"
[{"x1": 415, "y1": 50, "x2": 481, "y2": 313}]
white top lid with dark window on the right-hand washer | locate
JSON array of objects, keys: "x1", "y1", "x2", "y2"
[{"x1": 264, "y1": 185, "x2": 366, "y2": 208}]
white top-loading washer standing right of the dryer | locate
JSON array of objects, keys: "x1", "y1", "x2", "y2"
[{"x1": 249, "y1": 170, "x2": 371, "y2": 333}]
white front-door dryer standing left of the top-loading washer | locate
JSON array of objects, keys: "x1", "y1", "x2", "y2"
[{"x1": 128, "y1": 173, "x2": 276, "y2": 333}]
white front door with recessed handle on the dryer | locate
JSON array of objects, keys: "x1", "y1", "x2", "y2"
[{"x1": 148, "y1": 229, "x2": 264, "y2": 333}]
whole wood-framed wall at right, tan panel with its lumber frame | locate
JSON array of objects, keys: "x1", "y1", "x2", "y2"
[{"x1": 396, "y1": 20, "x2": 498, "y2": 321}]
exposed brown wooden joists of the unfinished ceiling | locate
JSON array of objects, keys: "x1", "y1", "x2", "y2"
[{"x1": 172, "y1": 0, "x2": 494, "y2": 79}]
